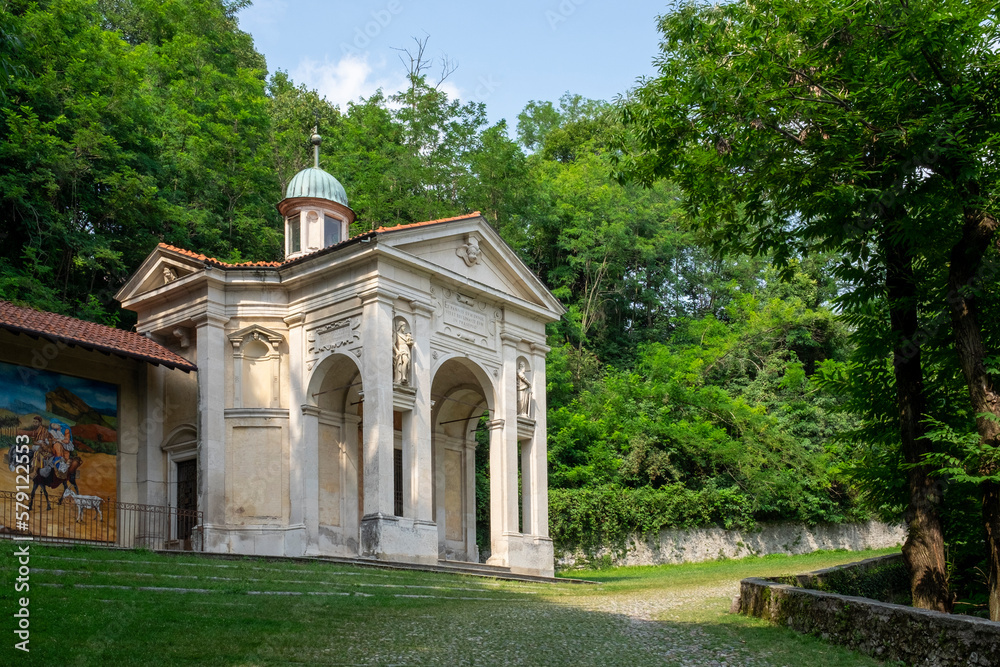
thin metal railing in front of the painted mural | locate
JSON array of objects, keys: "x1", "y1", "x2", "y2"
[{"x1": 0, "y1": 490, "x2": 202, "y2": 551}]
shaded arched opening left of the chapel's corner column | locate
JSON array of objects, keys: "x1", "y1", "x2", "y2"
[{"x1": 305, "y1": 354, "x2": 364, "y2": 555}]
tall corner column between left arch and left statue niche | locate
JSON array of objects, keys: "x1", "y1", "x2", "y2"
[{"x1": 359, "y1": 288, "x2": 395, "y2": 556}]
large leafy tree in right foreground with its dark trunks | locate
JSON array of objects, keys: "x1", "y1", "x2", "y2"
[{"x1": 620, "y1": 0, "x2": 1000, "y2": 619}]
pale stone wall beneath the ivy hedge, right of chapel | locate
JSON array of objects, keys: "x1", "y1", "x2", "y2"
[{"x1": 556, "y1": 521, "x2": 906, "y2": 568}]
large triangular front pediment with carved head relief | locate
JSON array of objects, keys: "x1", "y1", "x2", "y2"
[{"x1": 380, "y1": 216, "x2": 564, "y2": 318}]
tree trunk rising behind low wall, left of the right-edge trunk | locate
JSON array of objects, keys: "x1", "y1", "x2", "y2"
[{"x1": 885, "y1": 241, "x2": 952, "y2": 612}]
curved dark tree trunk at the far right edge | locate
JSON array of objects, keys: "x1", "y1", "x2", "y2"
[{"x1": 948, "y1": 206, "x2": 1000, "y2": 621}]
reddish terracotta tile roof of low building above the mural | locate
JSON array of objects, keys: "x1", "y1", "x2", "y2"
[{"x1": 0, "y1": 301, "x2": 198, "y2": 371}]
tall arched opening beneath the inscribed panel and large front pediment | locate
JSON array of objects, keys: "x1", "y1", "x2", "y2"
[{"x1": 431, "y1": 358, "x2": 499, "y2": 562}]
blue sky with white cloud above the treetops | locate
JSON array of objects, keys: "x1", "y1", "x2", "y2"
[{"x1": 239, "y1": 0, "x2": 667, "y2": 134}]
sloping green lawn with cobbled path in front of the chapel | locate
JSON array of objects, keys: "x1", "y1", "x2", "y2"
[{"x1": 0, "y1": 541, "x2": 904, "y2": 667}]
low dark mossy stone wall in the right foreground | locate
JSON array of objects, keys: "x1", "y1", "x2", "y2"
[{"x1": 734, "y1": 556, "x2": 1000, "y2": 667}]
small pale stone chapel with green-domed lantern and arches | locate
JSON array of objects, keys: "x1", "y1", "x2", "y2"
[{"x1": 107, "y1": 134, "x2": 565, "y2": 576}]
